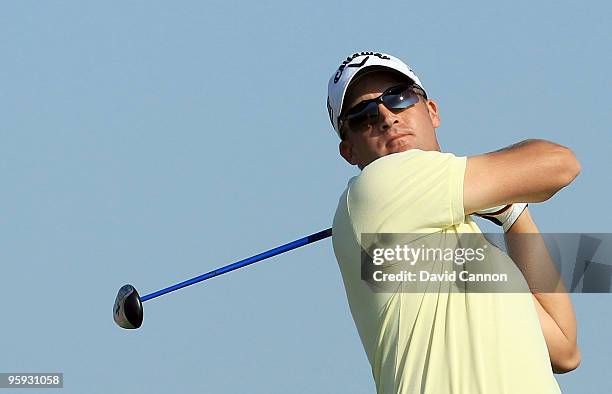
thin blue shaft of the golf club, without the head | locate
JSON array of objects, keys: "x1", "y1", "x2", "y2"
[{"x1": 140, "y1": 228, "x2": 331, "y2": 302}]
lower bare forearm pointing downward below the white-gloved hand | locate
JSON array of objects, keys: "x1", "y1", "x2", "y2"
[{"x1": 505, "y1": 209, "x2": 580, "y2": 373}]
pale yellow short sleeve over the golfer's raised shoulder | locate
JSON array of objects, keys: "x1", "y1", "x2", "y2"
[{"x1": 348, "y1": 149, "x2": 467, "y2": 233}]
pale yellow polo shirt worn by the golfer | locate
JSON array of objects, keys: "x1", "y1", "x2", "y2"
[{"x1": 333, "y1": 149, "x2": 560, "y2": 394}]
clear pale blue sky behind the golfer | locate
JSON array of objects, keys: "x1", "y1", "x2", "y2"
[{"x1": 0, "y1": 0, "x2": 612, "y2": 394}]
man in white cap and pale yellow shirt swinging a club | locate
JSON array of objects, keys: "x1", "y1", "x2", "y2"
[{"x1": 327, "y1": 52, "x2": 580, "y2": 394}]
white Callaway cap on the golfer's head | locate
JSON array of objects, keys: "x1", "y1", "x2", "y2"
[{"x1": 327, "y1": 52, "x2": 425, "y2": 137}]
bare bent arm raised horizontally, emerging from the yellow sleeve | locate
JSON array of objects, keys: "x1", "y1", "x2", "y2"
[{"x1": 463, "y1": 140, "x2": 580, "y2": 215}]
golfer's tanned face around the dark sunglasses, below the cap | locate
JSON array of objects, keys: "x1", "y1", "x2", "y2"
[{"x1": 340, "y1": 72, "x2": 440, "y2": 169}]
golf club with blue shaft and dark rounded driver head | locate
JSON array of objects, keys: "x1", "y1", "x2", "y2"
[{"x1": 113, "y1": 228, "x2": 332, "y2": 329}]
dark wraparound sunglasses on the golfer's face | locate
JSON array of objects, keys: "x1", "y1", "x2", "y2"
[{"x1": 338, "y1": 84, "x2": 427, "y2": 133}]
